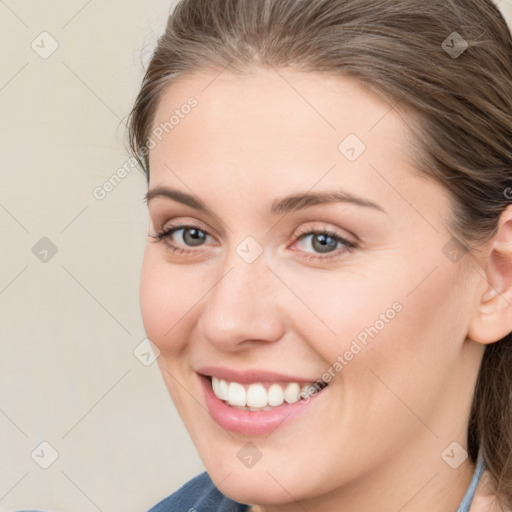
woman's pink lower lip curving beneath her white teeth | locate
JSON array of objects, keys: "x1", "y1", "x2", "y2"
[{"x1": 199, "y1": 375, "x2": 329, "y2": 436}]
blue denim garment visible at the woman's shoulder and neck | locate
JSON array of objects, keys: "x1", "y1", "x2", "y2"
[{"x1": 148, "y1": 450, "x2": 484, "y2": 512}]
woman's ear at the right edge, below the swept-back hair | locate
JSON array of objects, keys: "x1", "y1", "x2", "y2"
[{"x1": 467, "y1": 205, "x2": 512, "y2": 344}]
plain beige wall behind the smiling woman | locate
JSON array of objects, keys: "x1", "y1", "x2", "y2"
[{"x1": 0, "y1": 0, "x2": 512, "y2": 512}]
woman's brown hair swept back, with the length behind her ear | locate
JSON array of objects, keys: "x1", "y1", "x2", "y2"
[{"x1": 128, "y1": 0, "x2": 512, "y2": 508}]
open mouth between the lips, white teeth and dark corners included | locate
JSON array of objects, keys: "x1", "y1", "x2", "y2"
[{"x1": 206, "y1": 376, "x2": 327, "y2": 411}]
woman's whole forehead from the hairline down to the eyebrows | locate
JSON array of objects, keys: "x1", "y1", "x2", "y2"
[{"x1": 150, "y1": 69, "x2": 444, "y2": 214}]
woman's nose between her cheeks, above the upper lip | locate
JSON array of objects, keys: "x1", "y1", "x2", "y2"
[{"x1": 198, "y1": 254, "x2": 285, "y2": 351}]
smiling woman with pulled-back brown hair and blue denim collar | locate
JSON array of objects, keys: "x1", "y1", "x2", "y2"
[{"x1": 129, "y1": 0, "x2": 512, "y2": 512}]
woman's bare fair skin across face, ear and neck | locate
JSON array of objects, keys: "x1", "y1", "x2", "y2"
[{"x1": 140, "y1": 69, "x2": 512, "y2": 512}]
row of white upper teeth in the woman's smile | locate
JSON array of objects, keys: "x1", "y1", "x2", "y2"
[{"x1": 212, "y1": 377, "x2": 314, "y2": 407}]
